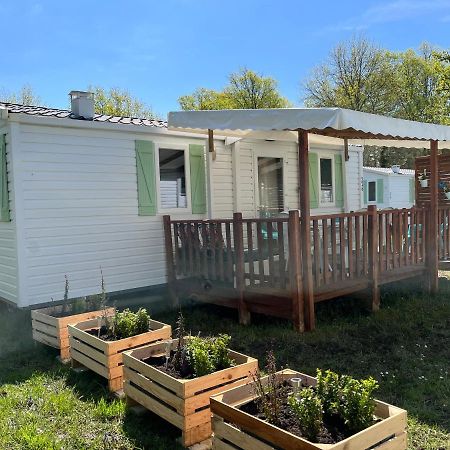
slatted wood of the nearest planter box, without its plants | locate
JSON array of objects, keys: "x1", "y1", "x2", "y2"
[{"x1": 211, "y1": 370, "x2": 406, "y2": 450}]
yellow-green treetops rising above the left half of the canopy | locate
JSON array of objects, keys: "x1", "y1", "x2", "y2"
[{"x1": 178, "y1": 69, "x2": 290, "y2": 110}]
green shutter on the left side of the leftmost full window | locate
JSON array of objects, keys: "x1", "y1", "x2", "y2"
[{"x1": 135, "y1": 141, "x2": 156, "y2": 216}]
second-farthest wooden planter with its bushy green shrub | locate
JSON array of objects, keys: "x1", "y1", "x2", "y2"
[{"x1": 68, "y1": 308, "x2": 172, "y2": 392}]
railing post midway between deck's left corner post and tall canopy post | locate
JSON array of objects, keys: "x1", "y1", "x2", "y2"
[{"x1": 233, "y1": 213, "x2": 251, "y2": 325}]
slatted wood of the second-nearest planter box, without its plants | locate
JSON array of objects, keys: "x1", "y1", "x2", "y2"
[{"x1": 123, "y1": 339, "x2": 258, "y2": 447}]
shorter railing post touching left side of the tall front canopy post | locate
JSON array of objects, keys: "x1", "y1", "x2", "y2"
[{"x1": 288, "y1": 210, "x2": 305, "y2": 333}]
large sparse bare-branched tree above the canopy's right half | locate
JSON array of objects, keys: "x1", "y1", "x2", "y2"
[{"x1": 304, "y1": 38, "x2": 395, "y2": 114}]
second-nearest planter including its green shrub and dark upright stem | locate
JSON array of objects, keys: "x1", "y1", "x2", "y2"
[{"x1": 123, "y1": 316, "x2": 258, "y2": 447}]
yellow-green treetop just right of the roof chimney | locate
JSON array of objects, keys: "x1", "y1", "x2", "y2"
[{"x1": 89, "y1": 86, "x2": 156, "y2": 119}]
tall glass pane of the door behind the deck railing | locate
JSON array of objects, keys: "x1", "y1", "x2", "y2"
[{"x1": 258, "y1": 157, "x2": 284, "y2": 216}]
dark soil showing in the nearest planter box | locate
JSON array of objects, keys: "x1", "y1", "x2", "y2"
[{"x1": 239, "y1": 383, "x2": 352, "y2": 444}]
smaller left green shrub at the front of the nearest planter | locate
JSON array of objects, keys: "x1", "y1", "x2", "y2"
[{"x1": 288, "y1": 388, "x2": 323, "y2": 441}]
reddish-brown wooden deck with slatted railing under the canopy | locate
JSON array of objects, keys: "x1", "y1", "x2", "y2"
[{"x1": 164, "y1": 206, "x2": 438, "y2": 331}]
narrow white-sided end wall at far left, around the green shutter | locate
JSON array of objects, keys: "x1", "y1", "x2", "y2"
[{"x1": 0, "y1": 127, "x2": 18, "y2": 303}]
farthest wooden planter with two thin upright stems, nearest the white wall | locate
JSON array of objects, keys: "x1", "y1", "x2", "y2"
[{"x1": 31, "y1": 276, "x2": 115, "y2": 361}]
